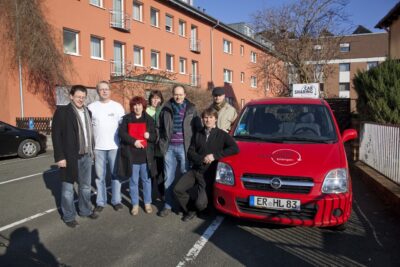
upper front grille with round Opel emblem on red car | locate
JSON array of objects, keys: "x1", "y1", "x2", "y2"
[{"x1": 241, "y1": 174, "x2": 314, "y2": 194}]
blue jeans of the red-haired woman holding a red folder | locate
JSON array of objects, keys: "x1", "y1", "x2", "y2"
[{"x1": 129, "y1": 163, "x2": 151, "y2": 206}]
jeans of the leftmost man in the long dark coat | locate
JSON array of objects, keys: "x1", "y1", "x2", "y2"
[{"x1": 61, "y1": 154, "x2": 92, "y2": 222}]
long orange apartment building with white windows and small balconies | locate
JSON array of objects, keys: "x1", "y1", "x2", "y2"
[{"x1": 0, "y1": 0, "x2": 273, "y2": 124}]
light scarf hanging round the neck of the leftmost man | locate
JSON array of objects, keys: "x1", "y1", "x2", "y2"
[{"x1": 72, "y1": 104, "x2": 94, "y2": 158}]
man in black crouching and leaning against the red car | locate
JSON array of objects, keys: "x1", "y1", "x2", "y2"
[{"x1": 174, "y1": 108, "x2": 239, "y2": 222}]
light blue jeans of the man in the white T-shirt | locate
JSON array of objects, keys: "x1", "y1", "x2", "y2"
[{"x1": 94, "y1": 149, "x2": 121, "y2": 207}]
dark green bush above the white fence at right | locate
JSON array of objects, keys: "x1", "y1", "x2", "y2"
[{"x1": 353, "y1": 60, "x2": 400, "y2": 124}]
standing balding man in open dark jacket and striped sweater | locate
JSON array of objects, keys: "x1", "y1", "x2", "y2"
[{"x1": 158, "y1": 85, "x2": 201, "y2": 217}]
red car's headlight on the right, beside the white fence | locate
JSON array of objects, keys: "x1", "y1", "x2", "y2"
[{"x1": 322, "y1": 169, "x2": 349, "y2": 194}]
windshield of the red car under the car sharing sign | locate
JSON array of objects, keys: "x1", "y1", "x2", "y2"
[{"x1": 234, "y1": 104, "x2": 337, "y2": 143}]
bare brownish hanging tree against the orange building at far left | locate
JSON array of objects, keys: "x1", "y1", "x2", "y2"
[{"x1": 0, "y1": 0, "x2": 72, "y2": 109}]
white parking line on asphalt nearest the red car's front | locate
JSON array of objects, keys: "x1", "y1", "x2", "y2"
[{"x1": 176, "y1": 216, "x2": 224, "y2": 267}]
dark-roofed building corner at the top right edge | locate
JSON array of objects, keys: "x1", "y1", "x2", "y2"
[{"x1": 375, "y1": 2, "x2": 400, "y2": 59}]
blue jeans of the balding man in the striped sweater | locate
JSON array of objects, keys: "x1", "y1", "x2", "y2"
[{"x1": 164, "y1": 144, "x2": 189, "y2": 209}]
